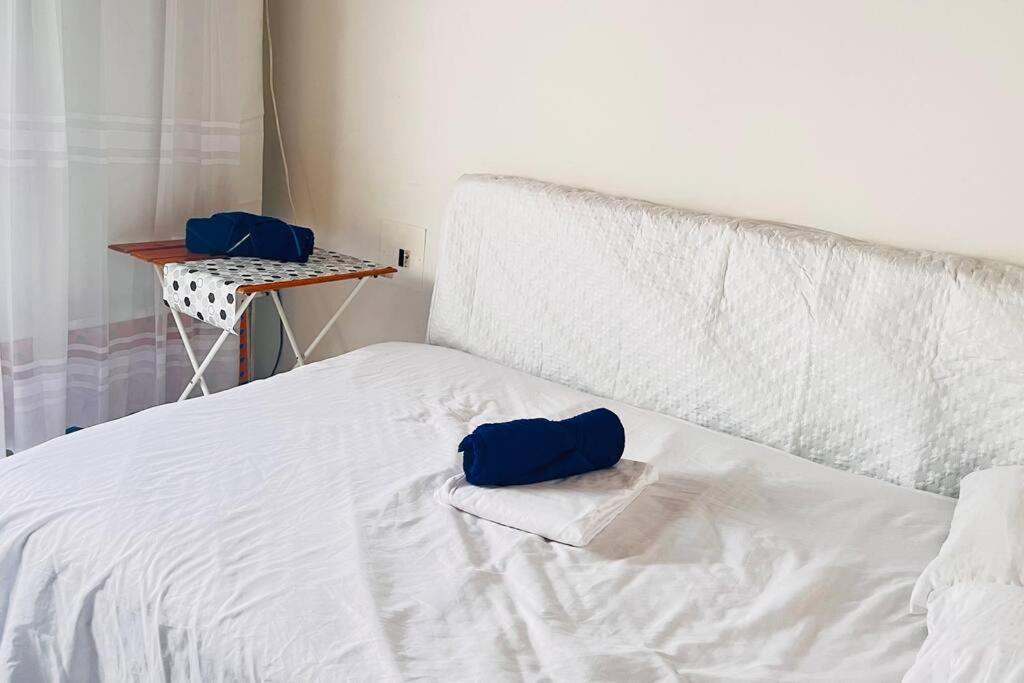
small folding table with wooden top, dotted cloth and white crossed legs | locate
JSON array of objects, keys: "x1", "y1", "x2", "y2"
[{"x1": 110, "y1": 240, "x2": 397, "y2": 401}]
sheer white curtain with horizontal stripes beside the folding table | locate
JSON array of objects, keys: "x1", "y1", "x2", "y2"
[{"x1": 0, "y1": 0, "x2": 263, "y2": 455}]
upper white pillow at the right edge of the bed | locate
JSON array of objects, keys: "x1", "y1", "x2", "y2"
[{"x1": 910, "y1": 466, "x2": 1024, "y2": 613}]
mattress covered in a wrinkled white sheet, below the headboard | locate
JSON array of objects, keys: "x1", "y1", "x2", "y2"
[{"x1": 0, "y1": 344, "x2": 954, "y2": 682}]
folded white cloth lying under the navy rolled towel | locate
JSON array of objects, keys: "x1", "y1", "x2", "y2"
[{"x1": 437, "y1": 460, "x2": 657, "y2": 547}]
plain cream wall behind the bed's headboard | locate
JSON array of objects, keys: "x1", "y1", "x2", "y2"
[{"x1": 263, "y1": 0, "x2": 1024, "y2": 368}]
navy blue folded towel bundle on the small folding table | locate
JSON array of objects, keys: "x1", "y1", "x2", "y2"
[{"x1": 185, "y1": 211, "x2": 313, "y2": 263}]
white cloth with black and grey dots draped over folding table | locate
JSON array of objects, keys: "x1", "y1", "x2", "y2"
[{"x1": 164, "y1": 249, "x2": 384, "y2": 334}]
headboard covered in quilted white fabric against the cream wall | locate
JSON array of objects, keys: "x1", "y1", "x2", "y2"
[{"x1": 428, "y1": 175, "x2": 1024, "y2": 496}]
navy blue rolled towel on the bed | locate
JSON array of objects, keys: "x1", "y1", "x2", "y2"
[{"x1": 459, "y1": 408, "x2": 626, "y2": 486}]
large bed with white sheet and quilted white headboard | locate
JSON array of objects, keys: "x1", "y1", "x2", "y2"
[{"x1": 0, "y1": 176, "x2": 1024, "y2": 682}]
